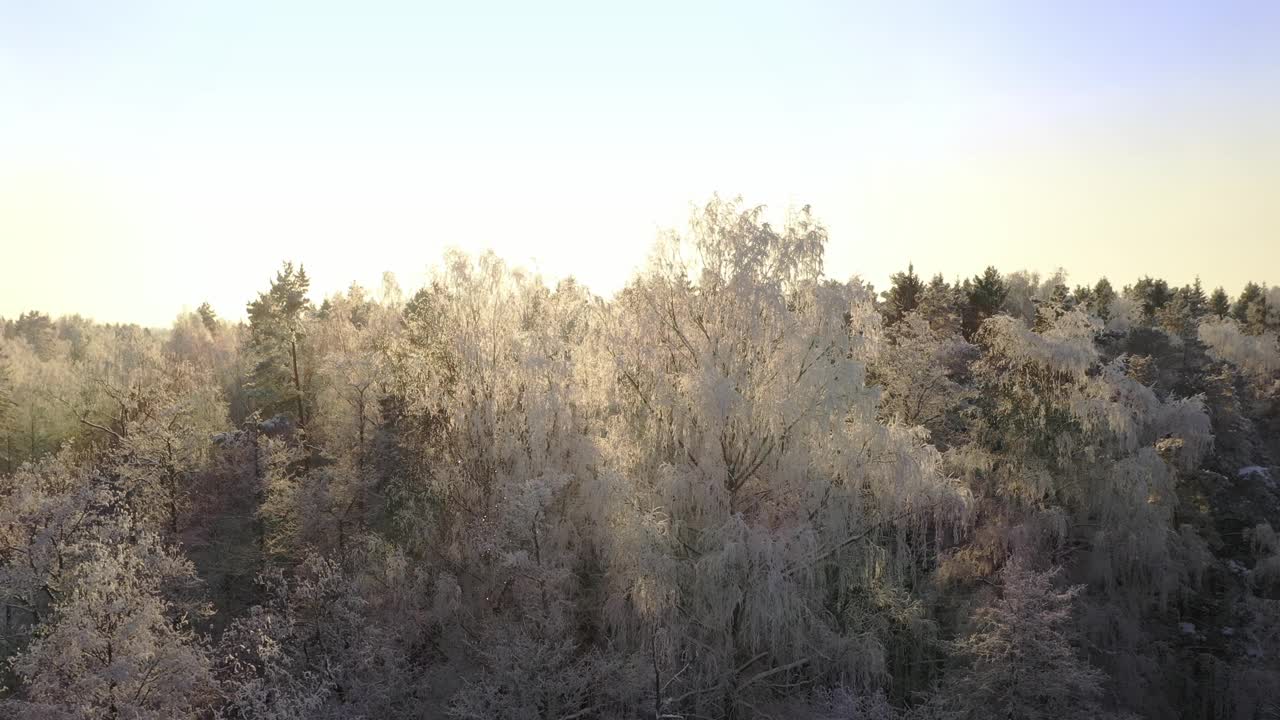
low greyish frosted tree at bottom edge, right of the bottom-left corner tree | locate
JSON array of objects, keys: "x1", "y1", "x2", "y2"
[{"x1": 218, "y1": 539, "x2": 431, "y2": 720}]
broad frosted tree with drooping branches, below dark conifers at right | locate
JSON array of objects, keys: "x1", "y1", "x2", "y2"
[{"x1": 965, "y1": 302, "x2": 1211, "y2": 603}]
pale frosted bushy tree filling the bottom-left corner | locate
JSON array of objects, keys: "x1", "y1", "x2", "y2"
[{"x1": 0, "y1": 528, "x2": 215, "y2": 720}]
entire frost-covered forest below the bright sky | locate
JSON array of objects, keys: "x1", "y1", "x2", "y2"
[{"x1": 0, "y1": 197, "x2": 1280, "y2": 720}]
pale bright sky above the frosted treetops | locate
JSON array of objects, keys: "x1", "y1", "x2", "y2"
[{"x1": 0, "y1": 0, "x2": 1280, "y2": 325}]
